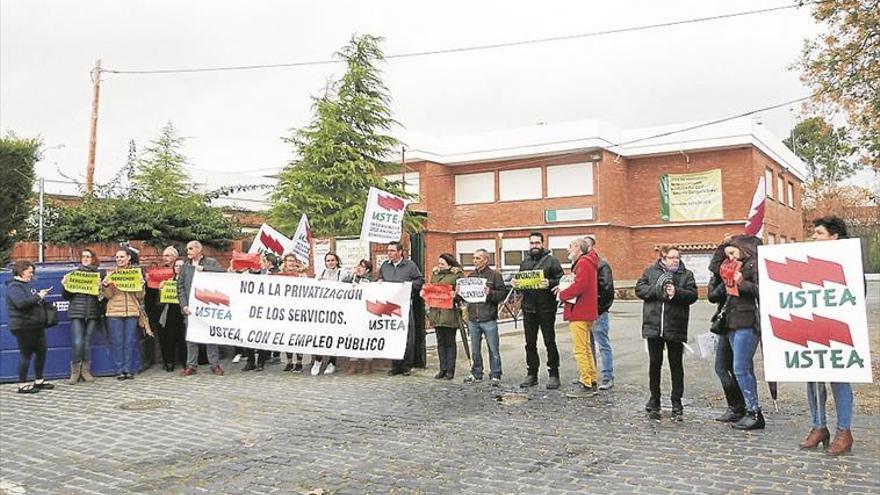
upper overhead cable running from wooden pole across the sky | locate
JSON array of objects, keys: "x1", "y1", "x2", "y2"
[{"x1": 101, "y1": 0, "x2": 831, "y2": 74}]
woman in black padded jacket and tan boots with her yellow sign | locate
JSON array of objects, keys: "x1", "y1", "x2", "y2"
[{"x1": 61, "y1": 249, "x2": 101, "y2": 385}]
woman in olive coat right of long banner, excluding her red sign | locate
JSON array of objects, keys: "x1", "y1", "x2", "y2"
[{"x1": 422, "y1": 253, "x2": 464, "y2": 380}]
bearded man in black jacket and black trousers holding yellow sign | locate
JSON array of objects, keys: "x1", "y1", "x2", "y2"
[{"x1": 514, "y1": 232, "x2": 564, "y2": 389}]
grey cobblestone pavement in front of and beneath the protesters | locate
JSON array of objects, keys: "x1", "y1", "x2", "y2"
[{"x1": 0, "y1": 288, "x2": 880, "y2": 495}]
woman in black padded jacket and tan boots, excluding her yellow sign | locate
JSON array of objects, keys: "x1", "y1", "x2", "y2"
[{"x1": 61, "y1": 249, "x2": 101, "y2": 385}]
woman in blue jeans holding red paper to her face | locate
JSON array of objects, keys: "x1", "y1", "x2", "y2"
[{"x1": 719, "y1": 236, "x2": 764, "y2": 430}]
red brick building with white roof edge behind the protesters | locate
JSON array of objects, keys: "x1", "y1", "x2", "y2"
[{"x1": 405, "y1": 119, "x2": 806, "y2": 285}]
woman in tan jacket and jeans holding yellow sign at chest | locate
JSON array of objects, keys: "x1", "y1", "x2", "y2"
[{"x1": 101, "y1": 249, "x2": 144, "y2": 380}]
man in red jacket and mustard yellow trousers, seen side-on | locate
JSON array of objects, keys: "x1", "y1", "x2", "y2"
[{"x1": 555, "y1": 239, "x2": 599, "y2": 398}]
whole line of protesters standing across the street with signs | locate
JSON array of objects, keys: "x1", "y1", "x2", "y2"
[{"x1": 6, "y1": 217, "x2": 853, "y2": 455}]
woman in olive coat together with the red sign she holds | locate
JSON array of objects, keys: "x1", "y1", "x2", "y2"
[{"x1": 421, "y1": 253, "x2": 464, "y2": 380}]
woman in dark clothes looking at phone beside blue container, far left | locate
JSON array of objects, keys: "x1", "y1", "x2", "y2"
[{"x1": 6, "y1": 260, "x2": 55, "y2": 394}]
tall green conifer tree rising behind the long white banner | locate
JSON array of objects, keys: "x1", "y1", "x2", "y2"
[{"x1": 269, "y1": 35, "x2": 418, "y2": 235}]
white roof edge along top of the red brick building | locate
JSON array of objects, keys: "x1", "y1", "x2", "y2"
[{"x1": 401, "y1": 117, "x2": 807, "y2": 180}]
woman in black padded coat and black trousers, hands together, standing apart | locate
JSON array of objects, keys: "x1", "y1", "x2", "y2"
[{"x1": 636, "y1": 245, "x2": 697, "y2": 421}]
